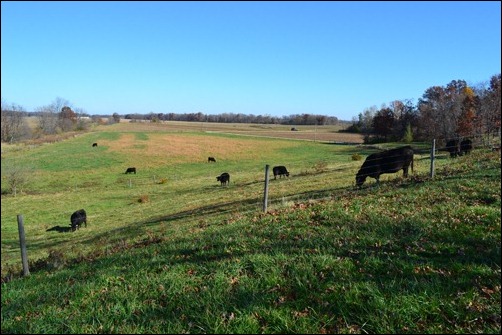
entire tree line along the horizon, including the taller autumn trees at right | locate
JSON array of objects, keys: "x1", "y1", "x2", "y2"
[{"x1": 1, "y1": 74, "x2": 501, "y2": 143}]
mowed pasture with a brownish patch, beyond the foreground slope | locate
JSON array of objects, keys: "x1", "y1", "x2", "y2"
[{"x1": 1, "y1": 122, "x2": 412, "y2": 272}]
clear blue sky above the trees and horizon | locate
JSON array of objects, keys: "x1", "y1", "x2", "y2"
[{"x1": 1, "y1": 1, "x2": 501, "y2": 120}]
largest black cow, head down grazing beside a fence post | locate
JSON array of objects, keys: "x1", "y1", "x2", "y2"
[{"x1": 356, "y1": 145, "x2": 413, "y2": 187}]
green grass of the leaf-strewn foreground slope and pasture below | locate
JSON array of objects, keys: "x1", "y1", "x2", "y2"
[{"x1": 1, "y1": 125, "x2": 501, "y2": 334}]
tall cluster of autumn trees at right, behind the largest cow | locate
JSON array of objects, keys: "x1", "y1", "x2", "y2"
[{"x1": 347, "y1": 74, "x2": 501, "y2": 143}]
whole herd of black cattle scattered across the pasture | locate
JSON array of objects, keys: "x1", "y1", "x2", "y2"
[{"x1": 70, "y1": 138, "x2": 472, "y2": 231}]
